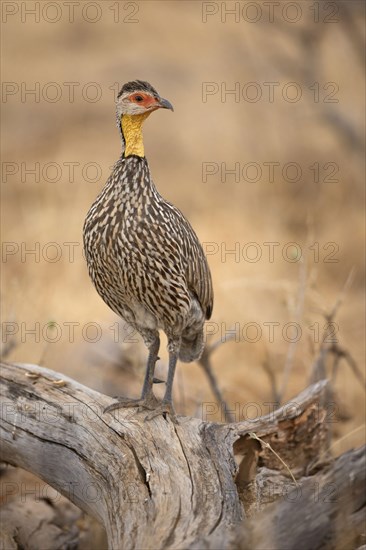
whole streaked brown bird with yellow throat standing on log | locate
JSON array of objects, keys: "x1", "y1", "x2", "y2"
[{"x1": 84, "y1": 80, "x2": 213, "y2": 420}]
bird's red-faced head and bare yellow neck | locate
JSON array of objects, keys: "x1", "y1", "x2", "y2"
[{"x1": 117, "y1": 80, "x2": 174, "y2": 157}]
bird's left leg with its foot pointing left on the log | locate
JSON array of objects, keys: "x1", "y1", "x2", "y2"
[{"x1": 104, "y1": 335, "x2": 160, "y2": 412}]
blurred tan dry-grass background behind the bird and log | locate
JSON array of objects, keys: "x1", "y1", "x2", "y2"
[{"x1": 1, "y1": 1, "x2": 365, "y2": 464}]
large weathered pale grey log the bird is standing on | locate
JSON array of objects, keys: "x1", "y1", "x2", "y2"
[{"x1": 0, "y1": 364, "x2": 364, "y2": 549}]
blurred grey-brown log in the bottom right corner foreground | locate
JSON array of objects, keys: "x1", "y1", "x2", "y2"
[{"x1": 191, "y1": 448, "x2": 366, "y2": 550}]
